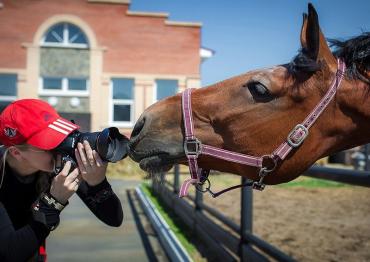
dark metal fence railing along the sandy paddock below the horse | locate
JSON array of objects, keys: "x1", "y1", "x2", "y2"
[{"x1": 148, "y1": 166, "x2": 370, "y2": 261}]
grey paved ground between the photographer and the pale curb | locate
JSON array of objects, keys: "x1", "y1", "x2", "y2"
[{"x1": 47, "y1": 180, "x2": 167, "y2": 262}]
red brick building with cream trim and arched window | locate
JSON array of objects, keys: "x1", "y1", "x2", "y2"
[{"x1": 0, "y1": 0, "x2": 211, "y2": 133}]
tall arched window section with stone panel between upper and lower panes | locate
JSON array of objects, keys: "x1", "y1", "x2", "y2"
[{"x1": 39, "y1": 22, "x2": 90, "y2": 96}]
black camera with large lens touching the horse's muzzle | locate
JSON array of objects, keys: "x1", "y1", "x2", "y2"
[{"x1": 53, "y1": 127, "x2": 129, "y2": 174}]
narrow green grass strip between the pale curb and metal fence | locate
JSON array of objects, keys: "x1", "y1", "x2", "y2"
[{"x1": 141, "y1": 183, "x2": 204, "y2": 261}]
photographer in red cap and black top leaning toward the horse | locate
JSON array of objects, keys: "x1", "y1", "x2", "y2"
[{"x1": 0, "y1": 99, "x2": 123, "y2": 261}]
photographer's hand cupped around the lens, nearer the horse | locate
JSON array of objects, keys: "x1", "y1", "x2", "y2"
[{"x1": 75, "y1": 140, "x2": 108, "y2": 186}]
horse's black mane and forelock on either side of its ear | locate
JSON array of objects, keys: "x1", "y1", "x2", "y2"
[{"x1": 289, "y1": 32, "x2": 370, "y2": 83}]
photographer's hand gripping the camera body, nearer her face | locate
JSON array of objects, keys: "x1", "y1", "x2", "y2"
[{"x1": 50, "y1": 161, "x2": 81, "y2": 205}]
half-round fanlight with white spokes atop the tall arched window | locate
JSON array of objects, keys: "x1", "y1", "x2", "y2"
[{"x1": 41, "y1": 23, "x2": 89, "y2": 48}]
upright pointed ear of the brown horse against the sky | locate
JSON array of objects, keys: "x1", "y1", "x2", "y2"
[{"x1": 301, "y1": 3, "x2": 337, "y2": 68}]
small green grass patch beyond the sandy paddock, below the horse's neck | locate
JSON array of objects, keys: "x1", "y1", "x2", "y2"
[{"x1": 278, "y1": 176, "x2": 349, "y2": 188}]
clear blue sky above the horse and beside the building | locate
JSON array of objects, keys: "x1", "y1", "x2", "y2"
[{"x1": 130, "y1": 0, "x2": 370, "y2": 86}]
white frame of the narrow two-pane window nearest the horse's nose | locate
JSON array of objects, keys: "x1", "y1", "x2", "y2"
[{"x1": 108, "y1": 77, "x2": 135, "y2": 128}]
